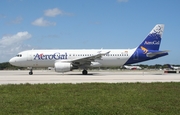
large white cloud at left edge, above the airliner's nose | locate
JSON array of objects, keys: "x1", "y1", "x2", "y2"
[{"x1": 0, "y1": 31, "x2": 32, "y2": 62}]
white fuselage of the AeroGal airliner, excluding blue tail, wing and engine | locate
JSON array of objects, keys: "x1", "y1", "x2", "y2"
[{"x1": 10, "y1": 49, "x2": 136, "y2": 67}]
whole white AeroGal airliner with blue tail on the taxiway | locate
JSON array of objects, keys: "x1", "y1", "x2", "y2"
[{"x1": 9, "y1": 24, "x2": 168, "y2": 75}]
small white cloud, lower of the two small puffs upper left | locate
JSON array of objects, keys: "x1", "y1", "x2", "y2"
[{"x1": 32, "y1": 17, "x2": 56, "y2": 26}]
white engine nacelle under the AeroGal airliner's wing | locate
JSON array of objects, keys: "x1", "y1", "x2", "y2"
[{"x1": 54, "y1": 62, "x2": 72, "y2": 73}]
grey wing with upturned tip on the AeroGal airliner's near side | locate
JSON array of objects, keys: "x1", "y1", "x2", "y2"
[{"x1": 59, "y1": 51, "x2": 110, "y2": 67}]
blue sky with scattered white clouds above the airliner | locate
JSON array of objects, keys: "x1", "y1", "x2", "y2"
[{"x1": 0, "y1": 0, "x2": 180, "y2": 65}]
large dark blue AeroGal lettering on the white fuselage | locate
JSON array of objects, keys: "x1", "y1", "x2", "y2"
[{"x1": 34, "y1": 52, "x2": 67, "y2": 60}]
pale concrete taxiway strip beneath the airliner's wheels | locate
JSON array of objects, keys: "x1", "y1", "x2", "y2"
[{"x1": 0, "y1": 70, "x2": 180, "y2": 85}]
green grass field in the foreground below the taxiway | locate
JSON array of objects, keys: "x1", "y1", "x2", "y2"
[{"x1": 0, "y1": 83, "x2": 180, "y2": 115}]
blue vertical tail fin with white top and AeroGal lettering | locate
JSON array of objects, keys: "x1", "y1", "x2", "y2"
[{"x1": 138, "y1": 24, "x2": 164, "y2": 52}]
